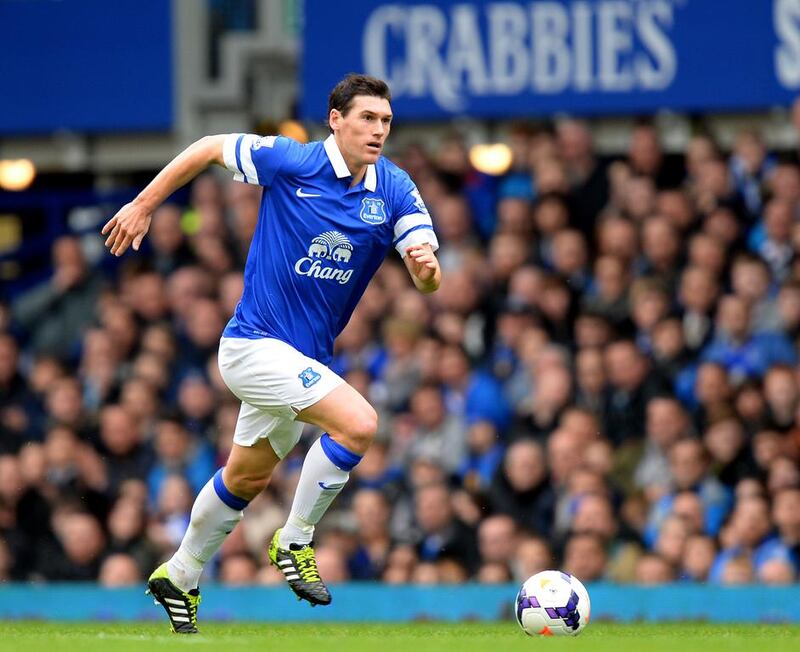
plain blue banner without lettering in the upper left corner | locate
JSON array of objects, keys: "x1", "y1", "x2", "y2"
[{"x1": 0, "y1": 0, "x2": 173, "y2": 135}]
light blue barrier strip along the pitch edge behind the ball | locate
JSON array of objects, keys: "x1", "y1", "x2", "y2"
[{"x1": 0, "y1": 583, "x2": 800, "y2": 623}]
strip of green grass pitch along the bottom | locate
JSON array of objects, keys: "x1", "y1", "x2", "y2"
[{"x1": 0, "y1": 621, "x2": 800, "y2": 652}]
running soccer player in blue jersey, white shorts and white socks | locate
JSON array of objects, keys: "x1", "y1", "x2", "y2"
[{"x1": 102, "y1": 75, "x2": 441, "y2": 633}]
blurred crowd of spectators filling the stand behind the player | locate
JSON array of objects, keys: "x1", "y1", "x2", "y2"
[{"x1": 0, "y1": 114, "x2": 800, "y2": 586}]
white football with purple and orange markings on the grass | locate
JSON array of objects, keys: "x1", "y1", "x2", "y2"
[{"x1": 516, "y1": 570, "x2": 591, "y2": 636}]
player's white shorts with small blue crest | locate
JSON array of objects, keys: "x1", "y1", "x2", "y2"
[{"x1": 217, "y1": 337, "x2": 344, "y2": 459}]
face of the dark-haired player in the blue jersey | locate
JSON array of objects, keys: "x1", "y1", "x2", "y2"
[{"x1": 329, "y1": 95, "x2": 392, "y2": 167}]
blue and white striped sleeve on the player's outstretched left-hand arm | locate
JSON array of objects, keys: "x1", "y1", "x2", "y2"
[{"x1": 222, "y1": 134, "x2": 299, "y2": 186}]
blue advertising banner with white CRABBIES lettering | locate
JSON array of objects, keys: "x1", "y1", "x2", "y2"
[{"x1": 302, "y1": 0, "x2": 800, "y2": 119}]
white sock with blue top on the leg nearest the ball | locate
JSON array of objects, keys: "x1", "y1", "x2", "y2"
[{"x1": 278, "y1": 433, "x2": 361, "y2": 548}]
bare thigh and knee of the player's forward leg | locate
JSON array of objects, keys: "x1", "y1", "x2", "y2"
[{"x1": 297, "y1": 383, "x2": 378, "y2": 453}]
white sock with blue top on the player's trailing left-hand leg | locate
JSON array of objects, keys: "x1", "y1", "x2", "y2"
[{"x1": 167, "y1": 469, "x2": 247, "y2": 591}]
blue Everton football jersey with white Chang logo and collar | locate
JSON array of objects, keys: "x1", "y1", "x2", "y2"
[{"x1": 223, "y1": 134, "x2": 438, "y2": 364}]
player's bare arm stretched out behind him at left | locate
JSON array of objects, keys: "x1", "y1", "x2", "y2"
[{"x1": 101, "y1": 135, "x2": 225, "y2": 256}]
